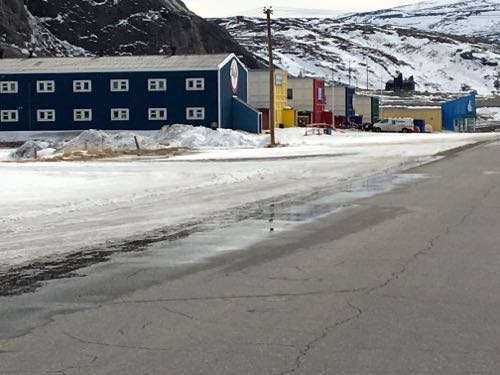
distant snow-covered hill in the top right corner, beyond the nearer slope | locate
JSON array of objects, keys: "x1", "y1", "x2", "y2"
[{"x1": 339, "y1": 0, "x2": 500, "y2": 42}]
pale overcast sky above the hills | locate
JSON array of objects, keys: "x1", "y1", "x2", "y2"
[{"x1": 184, "y1": 0, "x2": 420, "y2": 17}]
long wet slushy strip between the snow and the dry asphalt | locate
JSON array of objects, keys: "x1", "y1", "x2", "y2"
[{"x1": 0, "y1": 170, "x2": 429, "y2": 338}]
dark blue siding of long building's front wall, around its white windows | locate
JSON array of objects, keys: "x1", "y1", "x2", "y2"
[{"x1": 0, "y1": 71, "x2": 218, "y2": 131}]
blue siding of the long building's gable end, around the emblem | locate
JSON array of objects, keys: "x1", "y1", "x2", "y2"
[{"x1": 220, "y1": 59, "x2": 248, "y2": 130}]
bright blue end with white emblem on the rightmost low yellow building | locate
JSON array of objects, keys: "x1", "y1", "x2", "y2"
[{"x1": 441, "y1": 95, "x2": 477, "y2": 132}]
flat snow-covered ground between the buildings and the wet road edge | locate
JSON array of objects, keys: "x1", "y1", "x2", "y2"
[{"x1": 0, "y1": 129, "x2": 498, "y2": 269}]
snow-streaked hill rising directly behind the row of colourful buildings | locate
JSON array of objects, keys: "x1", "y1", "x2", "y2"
[{"x1": 215, "y1": 17, "x2": 500, "y2": 94}]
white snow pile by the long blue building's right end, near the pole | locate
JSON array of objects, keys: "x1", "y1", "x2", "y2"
[{"x1": 156, "y1": 125, "x2": 266, "y2": 148}]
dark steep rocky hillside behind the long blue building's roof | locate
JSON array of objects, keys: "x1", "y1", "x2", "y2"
[{"x1": 0, "y1": 0, "x2": 258, "y2": 66}]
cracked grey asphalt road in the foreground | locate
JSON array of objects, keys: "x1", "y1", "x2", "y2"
[{"x1": 0, "y1": 142, "x2": 500, "y2": 375}]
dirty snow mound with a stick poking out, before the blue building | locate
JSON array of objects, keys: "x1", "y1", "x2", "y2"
[{"x1": 62, "y1": 130, "x2": 159, "y2": 151}]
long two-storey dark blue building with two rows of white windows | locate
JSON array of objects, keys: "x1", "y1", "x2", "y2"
[{"x1": 0, "y1": 54, "x2": 260, "y2": 133}]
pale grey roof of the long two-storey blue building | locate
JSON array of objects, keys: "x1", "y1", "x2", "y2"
[{"x1": 0, "y1": 53, "x2": 235, "y2": 74}]
